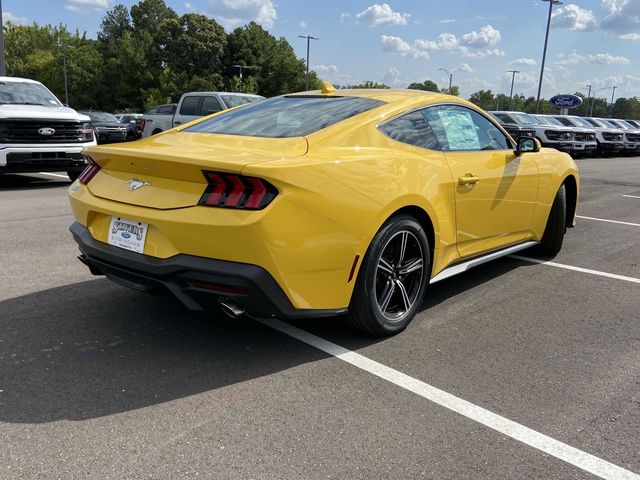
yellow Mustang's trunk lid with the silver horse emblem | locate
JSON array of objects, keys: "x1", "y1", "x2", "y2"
[{"x1": 85, "y1": 132, "x2": 308, "y2": 209}]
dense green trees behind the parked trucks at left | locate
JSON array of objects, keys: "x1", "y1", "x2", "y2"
[{"x1": 4, "y1": 0, "x2": 320, "y2": 112}]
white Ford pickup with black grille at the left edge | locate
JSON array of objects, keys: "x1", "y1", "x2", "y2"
[{"x1": 0, "y1": 77, "x2": 96, "y2": 180}]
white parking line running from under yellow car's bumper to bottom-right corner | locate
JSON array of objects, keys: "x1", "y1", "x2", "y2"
[{"x1": 257, "y1": 319, "x2": 640, "y2": 480}]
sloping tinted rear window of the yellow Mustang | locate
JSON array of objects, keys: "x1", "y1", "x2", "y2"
[{"x1": 183, "y1": 96, "x2": 384, "y2": 138}]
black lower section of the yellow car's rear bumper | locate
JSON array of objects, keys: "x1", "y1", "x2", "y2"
[{"x1": 70, "y1": 222, "x2": 347, "y2": 319}]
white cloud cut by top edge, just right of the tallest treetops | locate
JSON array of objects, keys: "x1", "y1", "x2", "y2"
[{"x1": 209, "y1": 0, "x2": 278, "y2": 28}]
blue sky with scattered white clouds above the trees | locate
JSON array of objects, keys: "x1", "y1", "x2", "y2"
[{"x1": 2, "y1": 0, "x2": 640, "y2": 97}]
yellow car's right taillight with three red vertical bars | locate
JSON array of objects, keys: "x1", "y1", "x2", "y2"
[{"x1": 199, "y1": 172, "x2": 278, "y2": 210}]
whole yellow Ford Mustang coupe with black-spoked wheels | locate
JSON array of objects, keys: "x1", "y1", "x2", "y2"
[{"x1": 69, "y1": 84, "x2": 579, "y2": 335}]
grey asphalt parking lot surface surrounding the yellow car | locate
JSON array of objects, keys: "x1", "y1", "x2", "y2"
[{"x1": 0, "y1": 158, "x2": 640, "y2": 479}]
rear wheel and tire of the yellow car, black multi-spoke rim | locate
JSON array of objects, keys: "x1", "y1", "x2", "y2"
[{"x1": 346, "y1": 215, "x2": 431, "y2": 336}]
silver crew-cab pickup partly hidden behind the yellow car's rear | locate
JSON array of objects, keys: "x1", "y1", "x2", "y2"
[{"x1": 141, "y1": 92, "x2": 264, "y2": 138}]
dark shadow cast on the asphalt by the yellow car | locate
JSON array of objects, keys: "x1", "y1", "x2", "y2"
[{"x1": 0, "y1": 260, "x2": 522, "y2": 423}]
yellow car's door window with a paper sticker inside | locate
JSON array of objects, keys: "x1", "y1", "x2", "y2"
[{"x1": 422, "y1": 105, "x2": 511, "y2": 151}]
